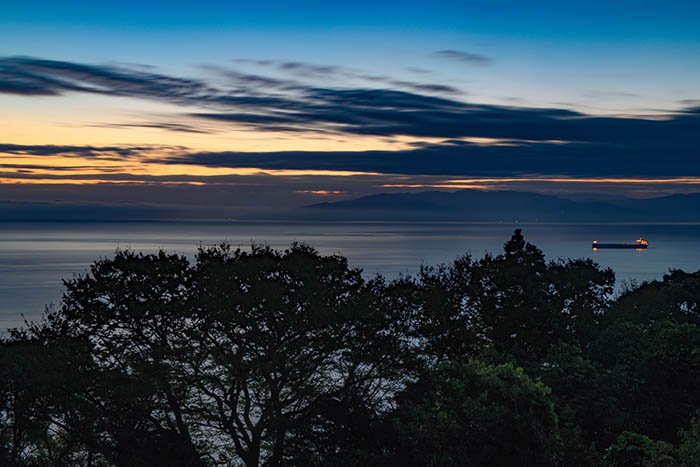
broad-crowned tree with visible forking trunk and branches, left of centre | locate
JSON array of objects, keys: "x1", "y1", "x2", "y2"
[{"x1": 188, "y1": 245, "x2": 405, "y2": 466}]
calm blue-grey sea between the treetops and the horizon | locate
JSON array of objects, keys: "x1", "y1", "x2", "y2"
[{"x1": 0, "y1": 222, "x2": 700, "y2": 329}]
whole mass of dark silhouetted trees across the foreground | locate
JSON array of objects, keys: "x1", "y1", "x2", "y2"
[{"x1": 0, "y1": 230, "x2": 700, "y2": 467}]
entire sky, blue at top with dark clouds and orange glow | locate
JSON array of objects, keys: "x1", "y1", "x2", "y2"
[{"x1": 0, "y1": 0, "x2": 700, "y2": 217}]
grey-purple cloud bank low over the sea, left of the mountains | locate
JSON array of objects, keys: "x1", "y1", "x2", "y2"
[{"x1": 0, "y1": 164, "x2": 402, "y2": 220}]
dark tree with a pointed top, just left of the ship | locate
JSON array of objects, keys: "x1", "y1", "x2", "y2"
[{"x1": 399, "y1": 229, "x2": 615, "y2": 366}]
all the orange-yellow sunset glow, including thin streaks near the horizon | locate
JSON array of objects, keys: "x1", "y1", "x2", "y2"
[{"x1": 0, "y1": 107, "x2": 700, "y2": 196}]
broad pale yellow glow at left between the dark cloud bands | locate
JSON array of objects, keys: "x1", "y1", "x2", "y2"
[{"x1": 0, "y1": 104, "x2": 508, "y2": 152}]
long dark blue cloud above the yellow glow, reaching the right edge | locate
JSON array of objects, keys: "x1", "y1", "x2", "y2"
[{"x1": 187, "y1": 84, "x2": 698, "y2": 150}]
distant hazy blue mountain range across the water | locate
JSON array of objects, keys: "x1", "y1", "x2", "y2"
[{"x1": 297, "y1": 189, "x2": 700, "y2": 222}]
